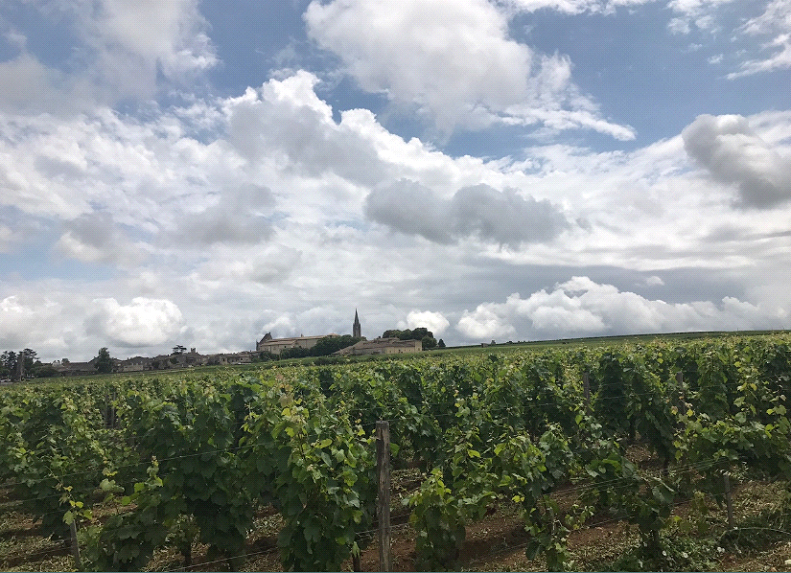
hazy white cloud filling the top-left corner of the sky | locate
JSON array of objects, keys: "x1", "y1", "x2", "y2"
[{"x1": 0, "y1": 0, "x2": 219, "y2": 115}]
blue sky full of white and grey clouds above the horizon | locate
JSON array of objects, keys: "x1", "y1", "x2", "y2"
[{"x1": 0, "y1": 0, "x2": 791, "y2": 361}]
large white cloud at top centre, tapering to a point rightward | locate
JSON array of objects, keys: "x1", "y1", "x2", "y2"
[{"x1": 304, "y1": 0, "x2": 634, "y2": 140}]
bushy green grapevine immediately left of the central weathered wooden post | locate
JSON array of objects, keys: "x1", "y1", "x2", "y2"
[{"x1": 244, "y1": 386, "x2": 375, "y2": 571}]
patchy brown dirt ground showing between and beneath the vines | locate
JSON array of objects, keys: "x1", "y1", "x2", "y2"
[{"x1": 0, "y1": 475, "x2": 791, "y2": 571}]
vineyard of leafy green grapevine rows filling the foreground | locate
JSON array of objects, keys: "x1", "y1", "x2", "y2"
[{"x1": 0, "y1": 335, "x2": 791, "y2": 571}]
